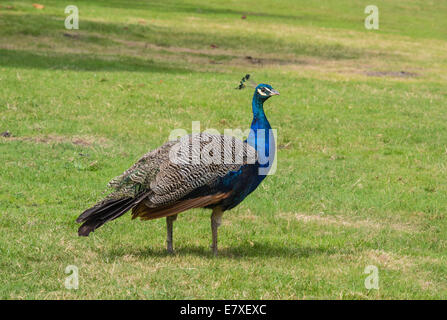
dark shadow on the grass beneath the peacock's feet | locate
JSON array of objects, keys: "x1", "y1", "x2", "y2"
[{"x1": 104, "y1": 243, "x2": 352, "y2": 259}]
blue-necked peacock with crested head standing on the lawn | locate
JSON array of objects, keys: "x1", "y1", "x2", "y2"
[{"x1": 76, "y1": 75, "x2": 279, "y2": 255}]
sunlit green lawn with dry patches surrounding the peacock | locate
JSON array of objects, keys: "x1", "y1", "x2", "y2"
[{"x1": 0, "y1": 0, "x2": 447, "y2": 299}]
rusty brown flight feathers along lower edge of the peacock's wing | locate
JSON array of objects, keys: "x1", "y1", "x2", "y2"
[{"x1": 132, "y1": 192, "x2": 231, "y2": 220}]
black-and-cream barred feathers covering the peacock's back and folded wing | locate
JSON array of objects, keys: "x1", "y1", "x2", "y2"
[{"x1": 109, "y1": 133, "x2": 256, "y2": 207}]
